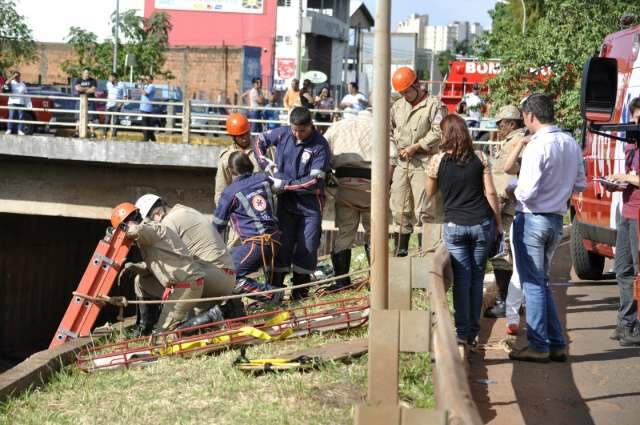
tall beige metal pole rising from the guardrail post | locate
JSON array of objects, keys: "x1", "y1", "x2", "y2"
[{"x1": 371, "y1": 0, "x2": 391, "y2": 309}]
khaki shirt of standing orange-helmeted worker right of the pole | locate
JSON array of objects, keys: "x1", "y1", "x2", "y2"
[{"x1": 391, "y1": 95, "x2": 442, "y2": 168}]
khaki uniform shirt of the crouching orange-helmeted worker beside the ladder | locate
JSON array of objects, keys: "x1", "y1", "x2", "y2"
[{"x1": 127, "y1": 220, "x2": 204, "y2": 287}]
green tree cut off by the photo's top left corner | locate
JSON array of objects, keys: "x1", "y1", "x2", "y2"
[{"x1": 0, "y1": 0, "x2": 37, "y2": 73}]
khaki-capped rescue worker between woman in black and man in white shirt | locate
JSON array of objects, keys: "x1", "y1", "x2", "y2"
[{"x1": 484, "y1": 105, "x2": 525, "y2": 325}]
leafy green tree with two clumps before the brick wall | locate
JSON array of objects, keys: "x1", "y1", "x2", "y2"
[{"x1": 62, "y1": 10, "x2": 173, "y2": 79}]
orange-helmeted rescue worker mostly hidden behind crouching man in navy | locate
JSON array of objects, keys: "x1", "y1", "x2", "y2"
[{"x1": 213, "y1": 112, "x2": 258, "y2": 248}]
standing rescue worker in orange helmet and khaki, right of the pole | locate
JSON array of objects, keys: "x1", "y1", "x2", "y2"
[{"x1": 391, "y1": 66, "x2": 442, "y2": 257}]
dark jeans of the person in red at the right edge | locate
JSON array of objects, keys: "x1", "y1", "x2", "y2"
[{"x1": 614, "y1": 214, "x2": 638, "y2": 328}]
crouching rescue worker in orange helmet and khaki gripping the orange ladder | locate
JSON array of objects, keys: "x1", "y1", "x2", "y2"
[{"x1": 111, "y1": 202, "x2": 204, "y2": 336}]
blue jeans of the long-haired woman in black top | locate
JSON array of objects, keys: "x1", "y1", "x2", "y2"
[{"x1": 443, "y1": 218, "x2": 496, "y2": 341}]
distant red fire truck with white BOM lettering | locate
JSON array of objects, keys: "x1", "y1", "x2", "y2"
[{"x1": 441, "y1": 60, "x2": 500, "y2": 113}]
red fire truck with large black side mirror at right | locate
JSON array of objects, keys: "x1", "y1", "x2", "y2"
[{"x1": 571, "y1": 26, "x2": 640, "y2": 279}]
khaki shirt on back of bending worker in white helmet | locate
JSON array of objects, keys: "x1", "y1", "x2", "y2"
[{"x1": 162, "y1": 204, "x2": 233, "y2": 270}]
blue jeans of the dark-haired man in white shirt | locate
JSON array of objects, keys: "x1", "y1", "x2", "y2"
[{"x1": 513, "y1": 212, "x2": 566, "y2": 353}]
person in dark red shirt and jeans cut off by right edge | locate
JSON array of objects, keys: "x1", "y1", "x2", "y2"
[{"x1": 608, "y1": 97, "x2": 640, "y2": 346}]
